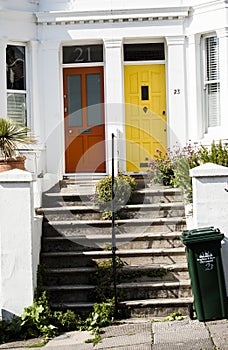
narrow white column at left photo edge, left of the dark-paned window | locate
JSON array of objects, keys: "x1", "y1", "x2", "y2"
[{"x1": 0, "y1": 39, "x2": 7, "y2": 118}]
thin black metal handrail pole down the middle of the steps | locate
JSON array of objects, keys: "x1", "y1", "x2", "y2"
[{"x1": 112, "y1": 133, "x2": 118, "y2": 318}]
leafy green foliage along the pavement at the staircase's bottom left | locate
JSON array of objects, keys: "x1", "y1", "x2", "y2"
[{"x1": 0, "y1": 292, "x2": 114, "y2": 347}]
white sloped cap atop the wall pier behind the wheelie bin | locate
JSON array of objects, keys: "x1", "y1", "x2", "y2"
[{"x1": 190, "y1": 163, "x2": 228, "y2": 177}]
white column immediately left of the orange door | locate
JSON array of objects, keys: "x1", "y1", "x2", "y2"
[{"x1": 38, "y1": 41, "x2": 64, "y2": 179}]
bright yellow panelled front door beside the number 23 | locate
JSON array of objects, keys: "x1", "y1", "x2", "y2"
[{"x1": 124, "y1": 64, "x2": 167, "y2": 172}]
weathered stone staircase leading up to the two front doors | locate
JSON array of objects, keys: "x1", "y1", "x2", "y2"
[{"x1": 39, "y1": 177, "x2": 192, "y2": 317}]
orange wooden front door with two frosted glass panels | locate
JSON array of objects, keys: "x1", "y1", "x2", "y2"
[{"x1": 63, "y1": 67, "x2": 105, "y2": 173}]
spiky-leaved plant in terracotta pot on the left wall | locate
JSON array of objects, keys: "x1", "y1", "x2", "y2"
[{"x1": 0, "y1": 118, "x2": 36, "y2": 172}]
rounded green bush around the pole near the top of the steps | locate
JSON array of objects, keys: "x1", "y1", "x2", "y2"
[{"x1": 94, "y1": 173, "x2": 136, "y2": 220}]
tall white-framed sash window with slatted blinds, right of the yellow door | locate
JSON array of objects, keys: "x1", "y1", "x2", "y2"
[{"x1": 203, "y1": 36, "x2": 220, "y2": 130}]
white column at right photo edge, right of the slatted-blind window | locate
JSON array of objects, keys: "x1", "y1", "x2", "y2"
[{"x1": 217, "y1": 28, "x2": 228, "y2": 139}]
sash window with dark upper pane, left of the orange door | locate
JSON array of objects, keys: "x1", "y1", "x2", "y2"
[{"x1": 6, "y1": 45, "x2": 27, "y2": 125}]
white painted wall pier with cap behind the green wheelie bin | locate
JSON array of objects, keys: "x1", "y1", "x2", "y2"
[{"x1": 190, "y1": 163, "x2": 228, "y2": 295}]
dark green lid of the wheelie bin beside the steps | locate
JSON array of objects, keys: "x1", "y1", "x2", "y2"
[{"x1": 182, "y1": 226, "x2": 224, "y2": 245}]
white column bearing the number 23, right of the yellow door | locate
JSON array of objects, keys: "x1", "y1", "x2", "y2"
[{"x1": 166, "y1": 36, "x2": 187, "y2": 148}]
